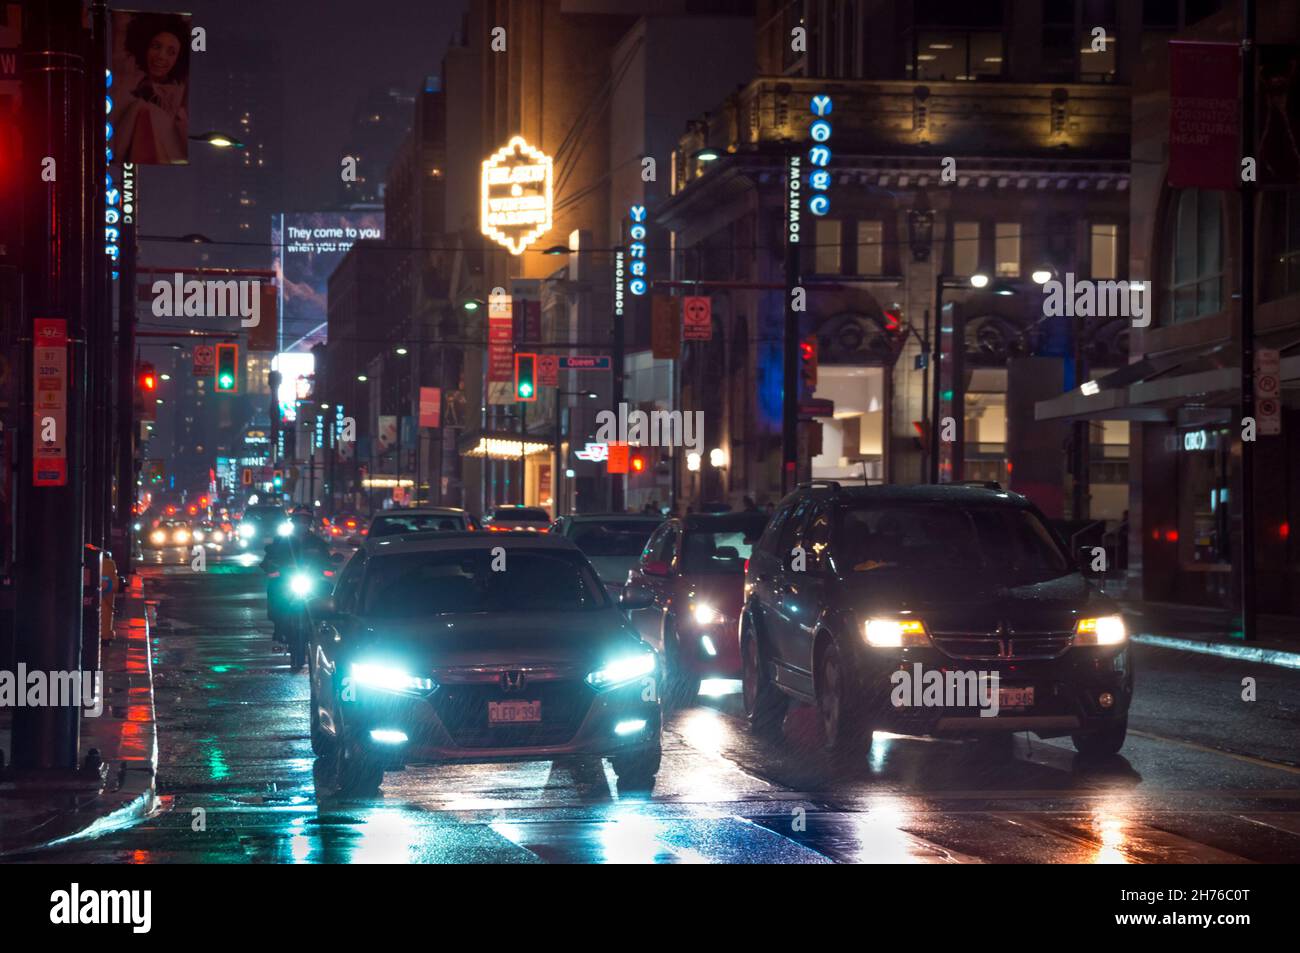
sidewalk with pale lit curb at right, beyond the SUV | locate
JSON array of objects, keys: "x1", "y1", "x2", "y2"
[{"x1": 1121, "y1": 599, "x2": 1300, "y2": 668}]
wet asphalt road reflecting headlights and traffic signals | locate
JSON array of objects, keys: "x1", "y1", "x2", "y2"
[{"x1": 29, "y1": 559, "x2": 1300, "y2": 863}]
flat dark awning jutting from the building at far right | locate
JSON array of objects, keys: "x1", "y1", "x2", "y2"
[{"x1": 1034, "y1": 332, "x2": 1300, "y2": 421}]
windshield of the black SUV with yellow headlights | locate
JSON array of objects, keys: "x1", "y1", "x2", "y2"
[{"x1": 835, "y1": 501, "x2": 1074, "y2": 579}]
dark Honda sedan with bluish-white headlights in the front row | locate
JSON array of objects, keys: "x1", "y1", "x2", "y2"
[{"x1": 309, "y1": 532, "x2": 660, "y2": 794}]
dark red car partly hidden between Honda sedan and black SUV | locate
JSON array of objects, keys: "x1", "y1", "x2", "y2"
[{"x1": 628, "y1": 512, "x2": 767, "y2": 707}]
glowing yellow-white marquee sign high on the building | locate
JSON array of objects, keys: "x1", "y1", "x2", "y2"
[{"x1": 481, "y1": 135, "x2": 553, "y2": 255}]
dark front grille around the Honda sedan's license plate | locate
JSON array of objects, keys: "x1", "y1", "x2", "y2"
[{"x1": 432, "y1": 679, "x2": 595, "y2": 748}]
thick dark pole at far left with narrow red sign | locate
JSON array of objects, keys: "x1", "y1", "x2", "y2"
[{"x1": 13, "y1": 0, "x2": 89, "y2": 770}]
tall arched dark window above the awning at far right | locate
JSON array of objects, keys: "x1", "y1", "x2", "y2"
[{"x1": 1165, "y1": 189, "x2": 1223, "y2": 324}]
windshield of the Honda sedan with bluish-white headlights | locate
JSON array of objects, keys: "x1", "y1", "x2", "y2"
[{"x1": 361, "y1": 547, "x2": 611, "y2": 619}]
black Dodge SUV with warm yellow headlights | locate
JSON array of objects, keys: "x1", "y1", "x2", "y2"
[{"x1": 740, "y1": 481, "x2": 1134, "y2": 755}]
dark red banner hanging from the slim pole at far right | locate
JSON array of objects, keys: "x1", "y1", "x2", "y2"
[{"x1": 1169, "y1": 40, "x2": 1242, "y2": 190}]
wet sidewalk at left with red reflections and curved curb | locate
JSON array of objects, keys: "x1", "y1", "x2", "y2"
[{"x1": 0, "y1": 575, "x2": 157, "y2": 857}]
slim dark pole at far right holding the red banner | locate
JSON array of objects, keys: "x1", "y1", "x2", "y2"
[{"x1": 1238, "y1": 0, "x2": 1257, "y2": 642}]
